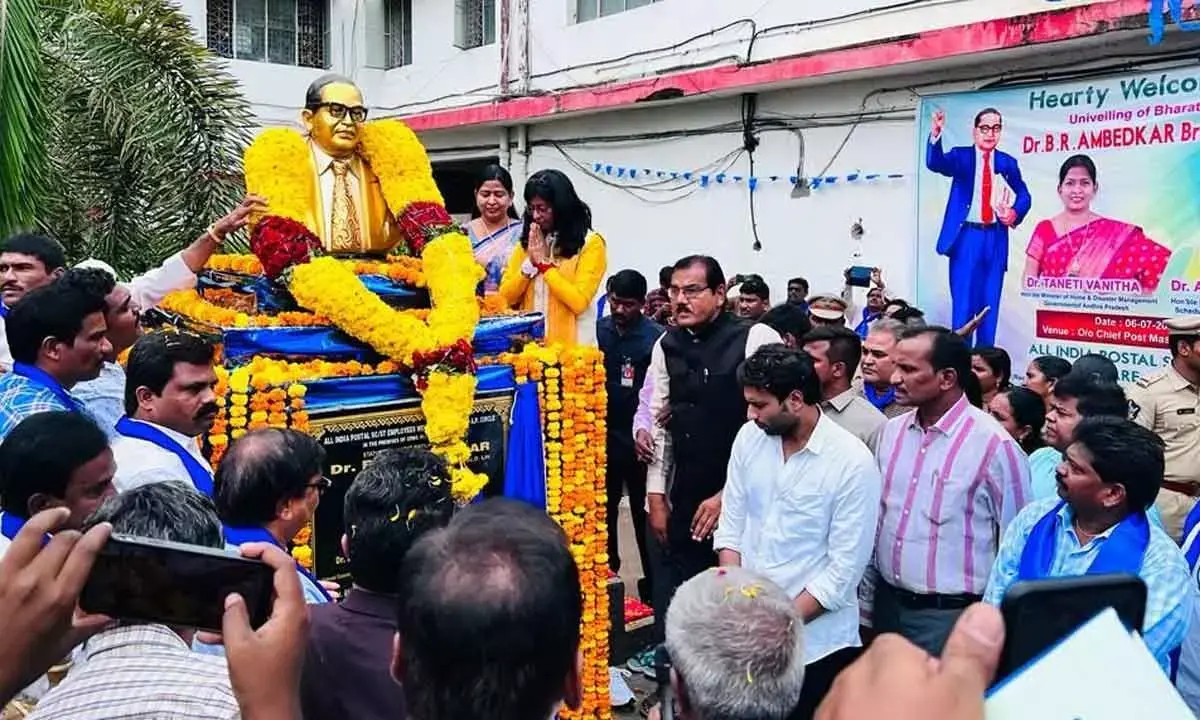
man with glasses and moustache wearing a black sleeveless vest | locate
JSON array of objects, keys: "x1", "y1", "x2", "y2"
[{"x1": 647, "y1": 256, "x2": 781, "y2": 622}]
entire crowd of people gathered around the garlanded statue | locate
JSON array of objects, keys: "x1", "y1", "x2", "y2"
[{"x1": 0, "y1": 158, "x2": 1200, "y2": 720}]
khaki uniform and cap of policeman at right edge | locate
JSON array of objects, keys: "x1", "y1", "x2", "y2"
[{"x1": 1128, "y1": 317, "x2": 1200, "y2": 542}]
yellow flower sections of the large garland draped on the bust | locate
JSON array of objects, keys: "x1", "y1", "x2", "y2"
[{"x1": 245, "y1": 119, "x2": 486, "y2": 501}]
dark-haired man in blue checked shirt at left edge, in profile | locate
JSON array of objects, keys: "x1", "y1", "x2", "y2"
[{"x1": 0, "y1": 282, "x2": 113, "y2": 439}]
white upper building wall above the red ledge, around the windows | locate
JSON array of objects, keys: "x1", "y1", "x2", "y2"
[{"x1": 179, "y1": 0, "x2": 1108, "y2": 125}]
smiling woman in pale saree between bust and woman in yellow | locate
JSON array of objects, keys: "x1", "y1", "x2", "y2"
[{"x1": 463, "y1": 164, "x2": 522, "y2": 294}]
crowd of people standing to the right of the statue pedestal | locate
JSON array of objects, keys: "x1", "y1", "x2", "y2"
[{"x1": 599, "y1": 256, "x2": 1200, "y2": 718}]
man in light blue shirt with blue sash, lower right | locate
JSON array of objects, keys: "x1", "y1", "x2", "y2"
[{"x1": 984, "y1": 416, "x2": 1194, "y2": 671}]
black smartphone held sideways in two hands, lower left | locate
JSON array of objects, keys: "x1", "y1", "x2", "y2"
[{"x1": 79, "y1": 535, "x2": 275, "y2": 632}]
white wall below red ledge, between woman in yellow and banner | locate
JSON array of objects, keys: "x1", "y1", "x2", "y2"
[{"x1": 520, "y1": 84, "x2": 914, "y2": 304}]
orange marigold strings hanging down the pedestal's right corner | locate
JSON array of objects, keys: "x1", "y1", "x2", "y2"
[{"x1": 496, "y1": 344, "x2": 612, "y2": 719}]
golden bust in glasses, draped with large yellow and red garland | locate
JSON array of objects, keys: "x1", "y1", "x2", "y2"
[{"x1": 242, "y1": 76, "x2": 487, "y2": 499}]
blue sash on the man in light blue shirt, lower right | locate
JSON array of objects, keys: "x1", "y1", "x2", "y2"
[{"x1": 1016, "y1": 500, "x2": 1150, "y2": 580}]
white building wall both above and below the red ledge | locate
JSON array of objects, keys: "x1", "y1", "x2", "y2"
[{"x1": 171, "y1": 0, "x2": 1200, "y2": 312}]
